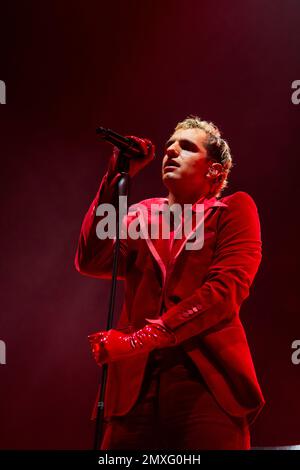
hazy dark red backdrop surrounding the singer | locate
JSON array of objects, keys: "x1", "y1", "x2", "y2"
[{"x1": 0, "y1": 0, "x2": 300, "y2": 449}]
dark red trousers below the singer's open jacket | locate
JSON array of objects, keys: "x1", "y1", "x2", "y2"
[{"x1": 101, "y1": 347, "x2": 250, "y2": 450}]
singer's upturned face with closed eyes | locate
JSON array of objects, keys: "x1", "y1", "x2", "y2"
[{"x1": 162, "y1": 129, "x2": 209, "y2": 193}]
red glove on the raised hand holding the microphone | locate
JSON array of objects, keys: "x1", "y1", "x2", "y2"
[{"x1": 108, "y1": 135, "x2": 155, "y2": 178}]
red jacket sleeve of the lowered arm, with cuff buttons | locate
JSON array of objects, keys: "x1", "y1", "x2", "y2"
[{"x1": 157, "y1": 192, "x2": 261, "y2": 343}]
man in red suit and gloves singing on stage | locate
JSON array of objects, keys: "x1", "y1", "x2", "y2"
[{"x1": 75, "y1": 117, "x2": 264, "y2": 450}]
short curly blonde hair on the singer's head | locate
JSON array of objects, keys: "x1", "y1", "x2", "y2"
[{"x1": 175, "y1": 115, "x2": 233, "y2": 196}]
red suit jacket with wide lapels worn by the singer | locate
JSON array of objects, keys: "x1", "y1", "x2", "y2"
[{"x1": 75, "y1": 174, "x2": 264, "y2": 423}]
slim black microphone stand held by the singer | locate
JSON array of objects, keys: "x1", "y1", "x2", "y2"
[{"x1": 94, "y1": 150, "x2": 130, "y2": 450}]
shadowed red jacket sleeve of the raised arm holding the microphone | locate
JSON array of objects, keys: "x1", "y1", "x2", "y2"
[{"x1": 75, "y1": 160, "x2": 127, "y2": 279}]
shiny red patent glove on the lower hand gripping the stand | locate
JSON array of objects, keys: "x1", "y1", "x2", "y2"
[{"x1": 88, "y1": 324, "x2": 176, "y2": 365}]
